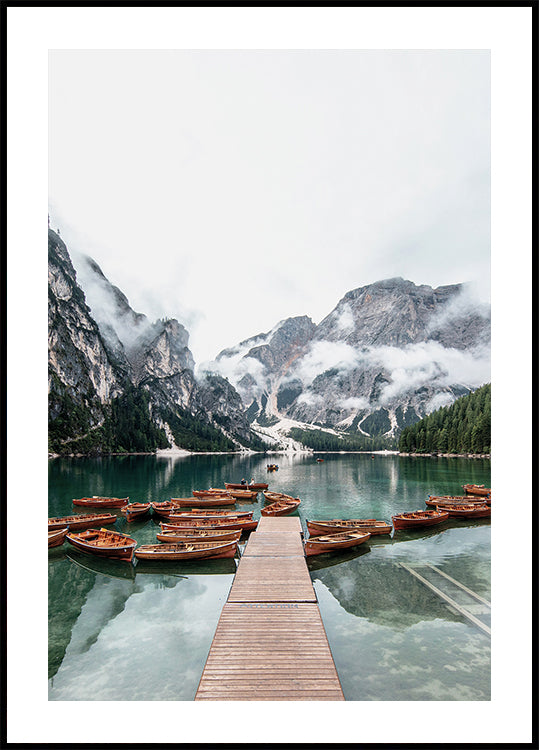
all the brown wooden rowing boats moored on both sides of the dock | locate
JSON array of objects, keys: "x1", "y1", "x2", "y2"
[{"x1": 49, "y1": 485, "x2": 491, "y2": 561}]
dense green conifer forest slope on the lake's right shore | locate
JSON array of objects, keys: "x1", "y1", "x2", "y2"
[{"x1": 399, "y1": 383, "x2": 490, "y2": 453}]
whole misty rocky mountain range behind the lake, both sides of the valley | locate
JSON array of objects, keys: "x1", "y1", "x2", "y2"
[{"x1": 49, "y1": 229, "x2": 490, "y2": 453}]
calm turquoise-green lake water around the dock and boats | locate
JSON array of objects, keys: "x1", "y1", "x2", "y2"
[{"x1": 49, "y1": 454, "x2": 490, "y2": 701}]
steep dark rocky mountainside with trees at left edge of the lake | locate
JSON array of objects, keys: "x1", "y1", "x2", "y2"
[{"x1": 49, "y1": 229, "x2": 261, "y2": 453}]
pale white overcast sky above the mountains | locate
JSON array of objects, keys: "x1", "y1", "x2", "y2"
[{"x1": 49, "y1": 50, "x2": 490, "y2": 363}]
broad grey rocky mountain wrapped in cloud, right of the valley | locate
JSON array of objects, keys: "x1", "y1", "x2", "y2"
[{"x1": 208, "y1": 278, "x2": 490, "y2": 440}]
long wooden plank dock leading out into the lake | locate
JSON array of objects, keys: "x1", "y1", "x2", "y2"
[{"x1": 195, "y1": 517, "x2": 344, "y2": 701}]
